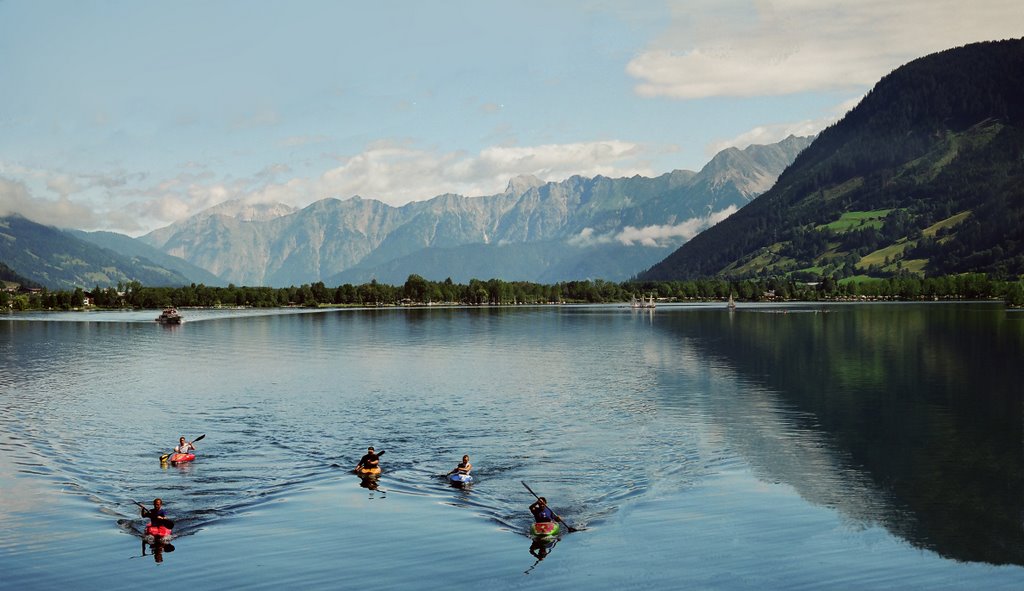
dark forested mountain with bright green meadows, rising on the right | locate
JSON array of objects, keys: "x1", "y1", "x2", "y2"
[{"x1": 639, "y1": 39, "x2": 1024, "y2": 281}]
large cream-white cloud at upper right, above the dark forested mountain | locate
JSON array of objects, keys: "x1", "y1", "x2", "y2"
[{"x1": 626, "y1": 0, "x2": 1024, "y2": 98}]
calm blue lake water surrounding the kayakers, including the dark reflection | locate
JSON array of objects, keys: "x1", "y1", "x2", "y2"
[{"x1": 0, "y1": 303, "x2": 1024, "y2": 590}]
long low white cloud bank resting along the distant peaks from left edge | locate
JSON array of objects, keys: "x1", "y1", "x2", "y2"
[{"x1": 0, "y1": 140, "x2": 653, "y2": 235}]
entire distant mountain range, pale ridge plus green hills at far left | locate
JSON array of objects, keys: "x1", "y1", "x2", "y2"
[{"x1": 0, "y1": 137, "x2": 811, "y2": 289}]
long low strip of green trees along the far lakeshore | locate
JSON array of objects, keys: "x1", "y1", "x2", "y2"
[{"x1": 0, "y1": 273, "x2": 1024, "y2": 312}]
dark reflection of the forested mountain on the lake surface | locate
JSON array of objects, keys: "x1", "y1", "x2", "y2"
[{"x1": 653, "y1": 304, "x2": 1024, "y2": 564}]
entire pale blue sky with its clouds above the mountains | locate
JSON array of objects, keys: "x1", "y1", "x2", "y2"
[{"x1": 0, "y1": 0, "x2": 1024, "y2": 236}]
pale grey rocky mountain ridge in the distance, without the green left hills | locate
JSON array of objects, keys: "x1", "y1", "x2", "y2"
[{"x1": 140, "y1": 136, "x2": 811, "y2": 286}]
